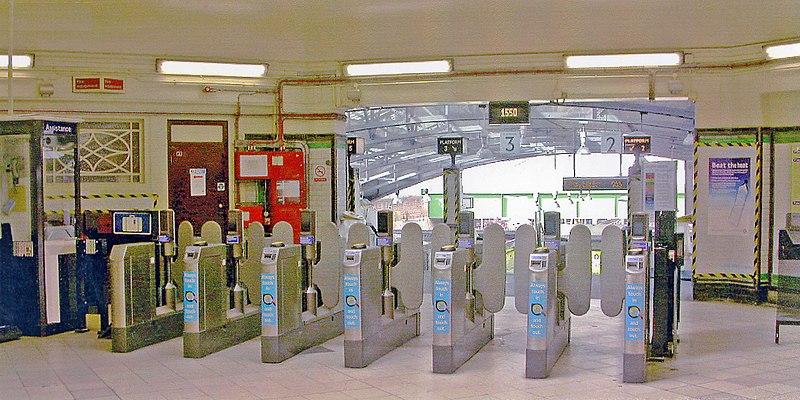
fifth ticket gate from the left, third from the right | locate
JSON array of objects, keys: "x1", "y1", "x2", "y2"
[{"x1": 431, "y1": 220, "x2": 505, "y2": 374}]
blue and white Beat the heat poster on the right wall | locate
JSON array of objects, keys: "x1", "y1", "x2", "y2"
[{"x1": 708, "y1": 157, "x2": 755, "y2": 236}]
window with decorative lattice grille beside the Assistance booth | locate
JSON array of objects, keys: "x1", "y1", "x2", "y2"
[{"x1": 45, "y1": 121, "x2": 144, "y2": 183}]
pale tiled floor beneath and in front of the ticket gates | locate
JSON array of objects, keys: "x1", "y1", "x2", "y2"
[{"x1": 0, "y1": 292, "x2": 800, "y2": 400}]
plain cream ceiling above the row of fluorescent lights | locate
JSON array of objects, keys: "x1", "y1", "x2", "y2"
[{"x1": 0, "y1": 0, "x2": 800, "y2": 62}]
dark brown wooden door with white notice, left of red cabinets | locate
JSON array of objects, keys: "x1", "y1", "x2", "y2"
[{"x1": 167, "y1": 120, "x2": 230, "y2": 230}]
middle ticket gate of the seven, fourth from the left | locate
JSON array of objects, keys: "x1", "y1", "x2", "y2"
[{"x1": 342, "y1": 211, "x2": 424, "y2": 368}]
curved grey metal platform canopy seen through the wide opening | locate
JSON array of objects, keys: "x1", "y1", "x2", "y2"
[{"x1": 346, "y1": 100, "x2": 694, "y2": 200}]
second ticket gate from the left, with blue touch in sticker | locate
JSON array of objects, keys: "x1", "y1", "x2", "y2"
[{"x1": 183, "y1": 210, "x2": 264, "y2": 358}]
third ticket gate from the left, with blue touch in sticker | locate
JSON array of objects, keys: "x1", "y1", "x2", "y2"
[{"x1": 261, "y1": 214, "x2": 344, "y2": 363}]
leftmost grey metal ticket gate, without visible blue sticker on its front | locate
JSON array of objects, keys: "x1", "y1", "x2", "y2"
[{"x1": 109, "y1": 210, "x2": 193, "y2": 353}]
